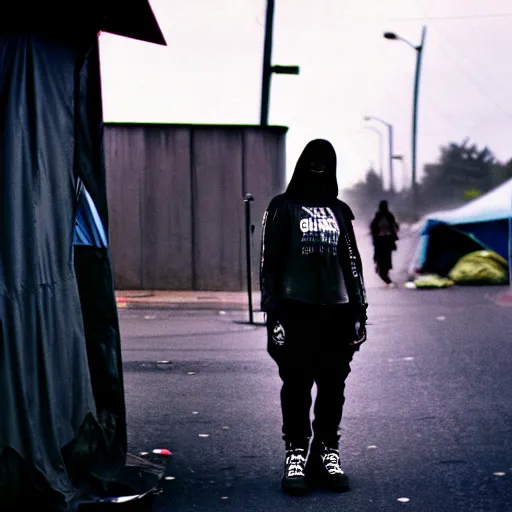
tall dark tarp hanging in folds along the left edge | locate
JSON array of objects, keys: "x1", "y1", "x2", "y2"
[{"x1": 0, "y1": 13, "x2": 166, "y2": 512}]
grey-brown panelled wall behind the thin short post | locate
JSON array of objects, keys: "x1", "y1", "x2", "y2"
[{"x1": 104, "y1": 123, "x2": 287, "y2": 291}]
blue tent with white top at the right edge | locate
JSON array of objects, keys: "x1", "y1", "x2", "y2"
[{"x1": 410, "y1": 179, "x2": 512, "y2": 275}]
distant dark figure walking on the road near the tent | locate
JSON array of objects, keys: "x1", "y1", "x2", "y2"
[{"x1": 370, "y1": 200, "x2": 400, "y2": 286}]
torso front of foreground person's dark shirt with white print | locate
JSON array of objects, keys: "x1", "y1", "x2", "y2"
[{"x1": 283, "y1": 206, "x2": 348, "y2": 305}]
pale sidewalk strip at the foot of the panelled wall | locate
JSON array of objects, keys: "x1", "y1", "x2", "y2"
[{"x1": 116, "y1": 290, "x2": 260, "y2": 311}]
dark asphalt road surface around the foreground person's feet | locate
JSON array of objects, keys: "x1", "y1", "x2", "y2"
[{"x1": 120, "y1": 280, "x2": 512, "y2": 512}]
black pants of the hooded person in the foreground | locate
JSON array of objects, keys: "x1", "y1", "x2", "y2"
[{"x1": 267, "y1": 302, "x2": 355, "y2": 446}]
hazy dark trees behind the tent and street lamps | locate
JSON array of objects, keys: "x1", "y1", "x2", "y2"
[{"x1": 341, "y1": 139, "x2": 512, "y2": 222}]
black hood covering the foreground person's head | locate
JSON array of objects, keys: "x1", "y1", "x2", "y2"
[{"x1": 285, "y1": 139, "x2": 338, "y2": 203}]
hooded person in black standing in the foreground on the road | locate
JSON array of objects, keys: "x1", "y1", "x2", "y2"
[{"x1": 260, "y1": 139, "x2": 367, "y2": 494}]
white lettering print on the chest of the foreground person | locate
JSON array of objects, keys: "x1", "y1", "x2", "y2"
[{"x1": 299, "y1": 206, "x2": 340, "y2": 256}]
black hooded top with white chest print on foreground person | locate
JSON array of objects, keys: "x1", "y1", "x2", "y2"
[{"x1": 260, "y1": 139, "x2": 367, "y2": 312}]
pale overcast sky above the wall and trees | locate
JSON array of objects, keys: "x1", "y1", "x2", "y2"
[{"x1": 100, "y1": 0, "x2": 512, "y2": 188}]
